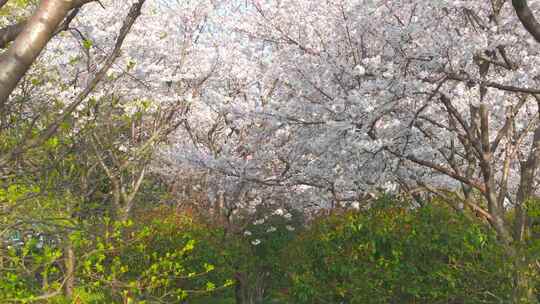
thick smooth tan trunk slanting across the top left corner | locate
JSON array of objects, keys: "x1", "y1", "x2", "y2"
[{"x1": 0, "y1": 0, "x2": 73, "y2": 105}]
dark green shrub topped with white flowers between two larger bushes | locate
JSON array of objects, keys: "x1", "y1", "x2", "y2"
[{"x1": 189, "y1": 206, "x2": 303, "y2": 304}]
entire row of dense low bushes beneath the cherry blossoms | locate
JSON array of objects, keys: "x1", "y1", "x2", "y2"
[{"x1": 0, "y1": 198, "x2": 524, "y2": 304}]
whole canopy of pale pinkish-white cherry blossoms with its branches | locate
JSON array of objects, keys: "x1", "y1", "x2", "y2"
[{"x1": 0, "y1": 0, "x2": 540, "y2": 303}]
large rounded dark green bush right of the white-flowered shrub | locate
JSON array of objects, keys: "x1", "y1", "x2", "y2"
[{"x1": 284, "y1": 199, "x2": 511, "y2": 303}]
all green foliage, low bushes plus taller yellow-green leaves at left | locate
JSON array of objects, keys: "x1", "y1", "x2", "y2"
[{"x1": 0, "y1": 99, "x2": 524, "y2": 304}]
